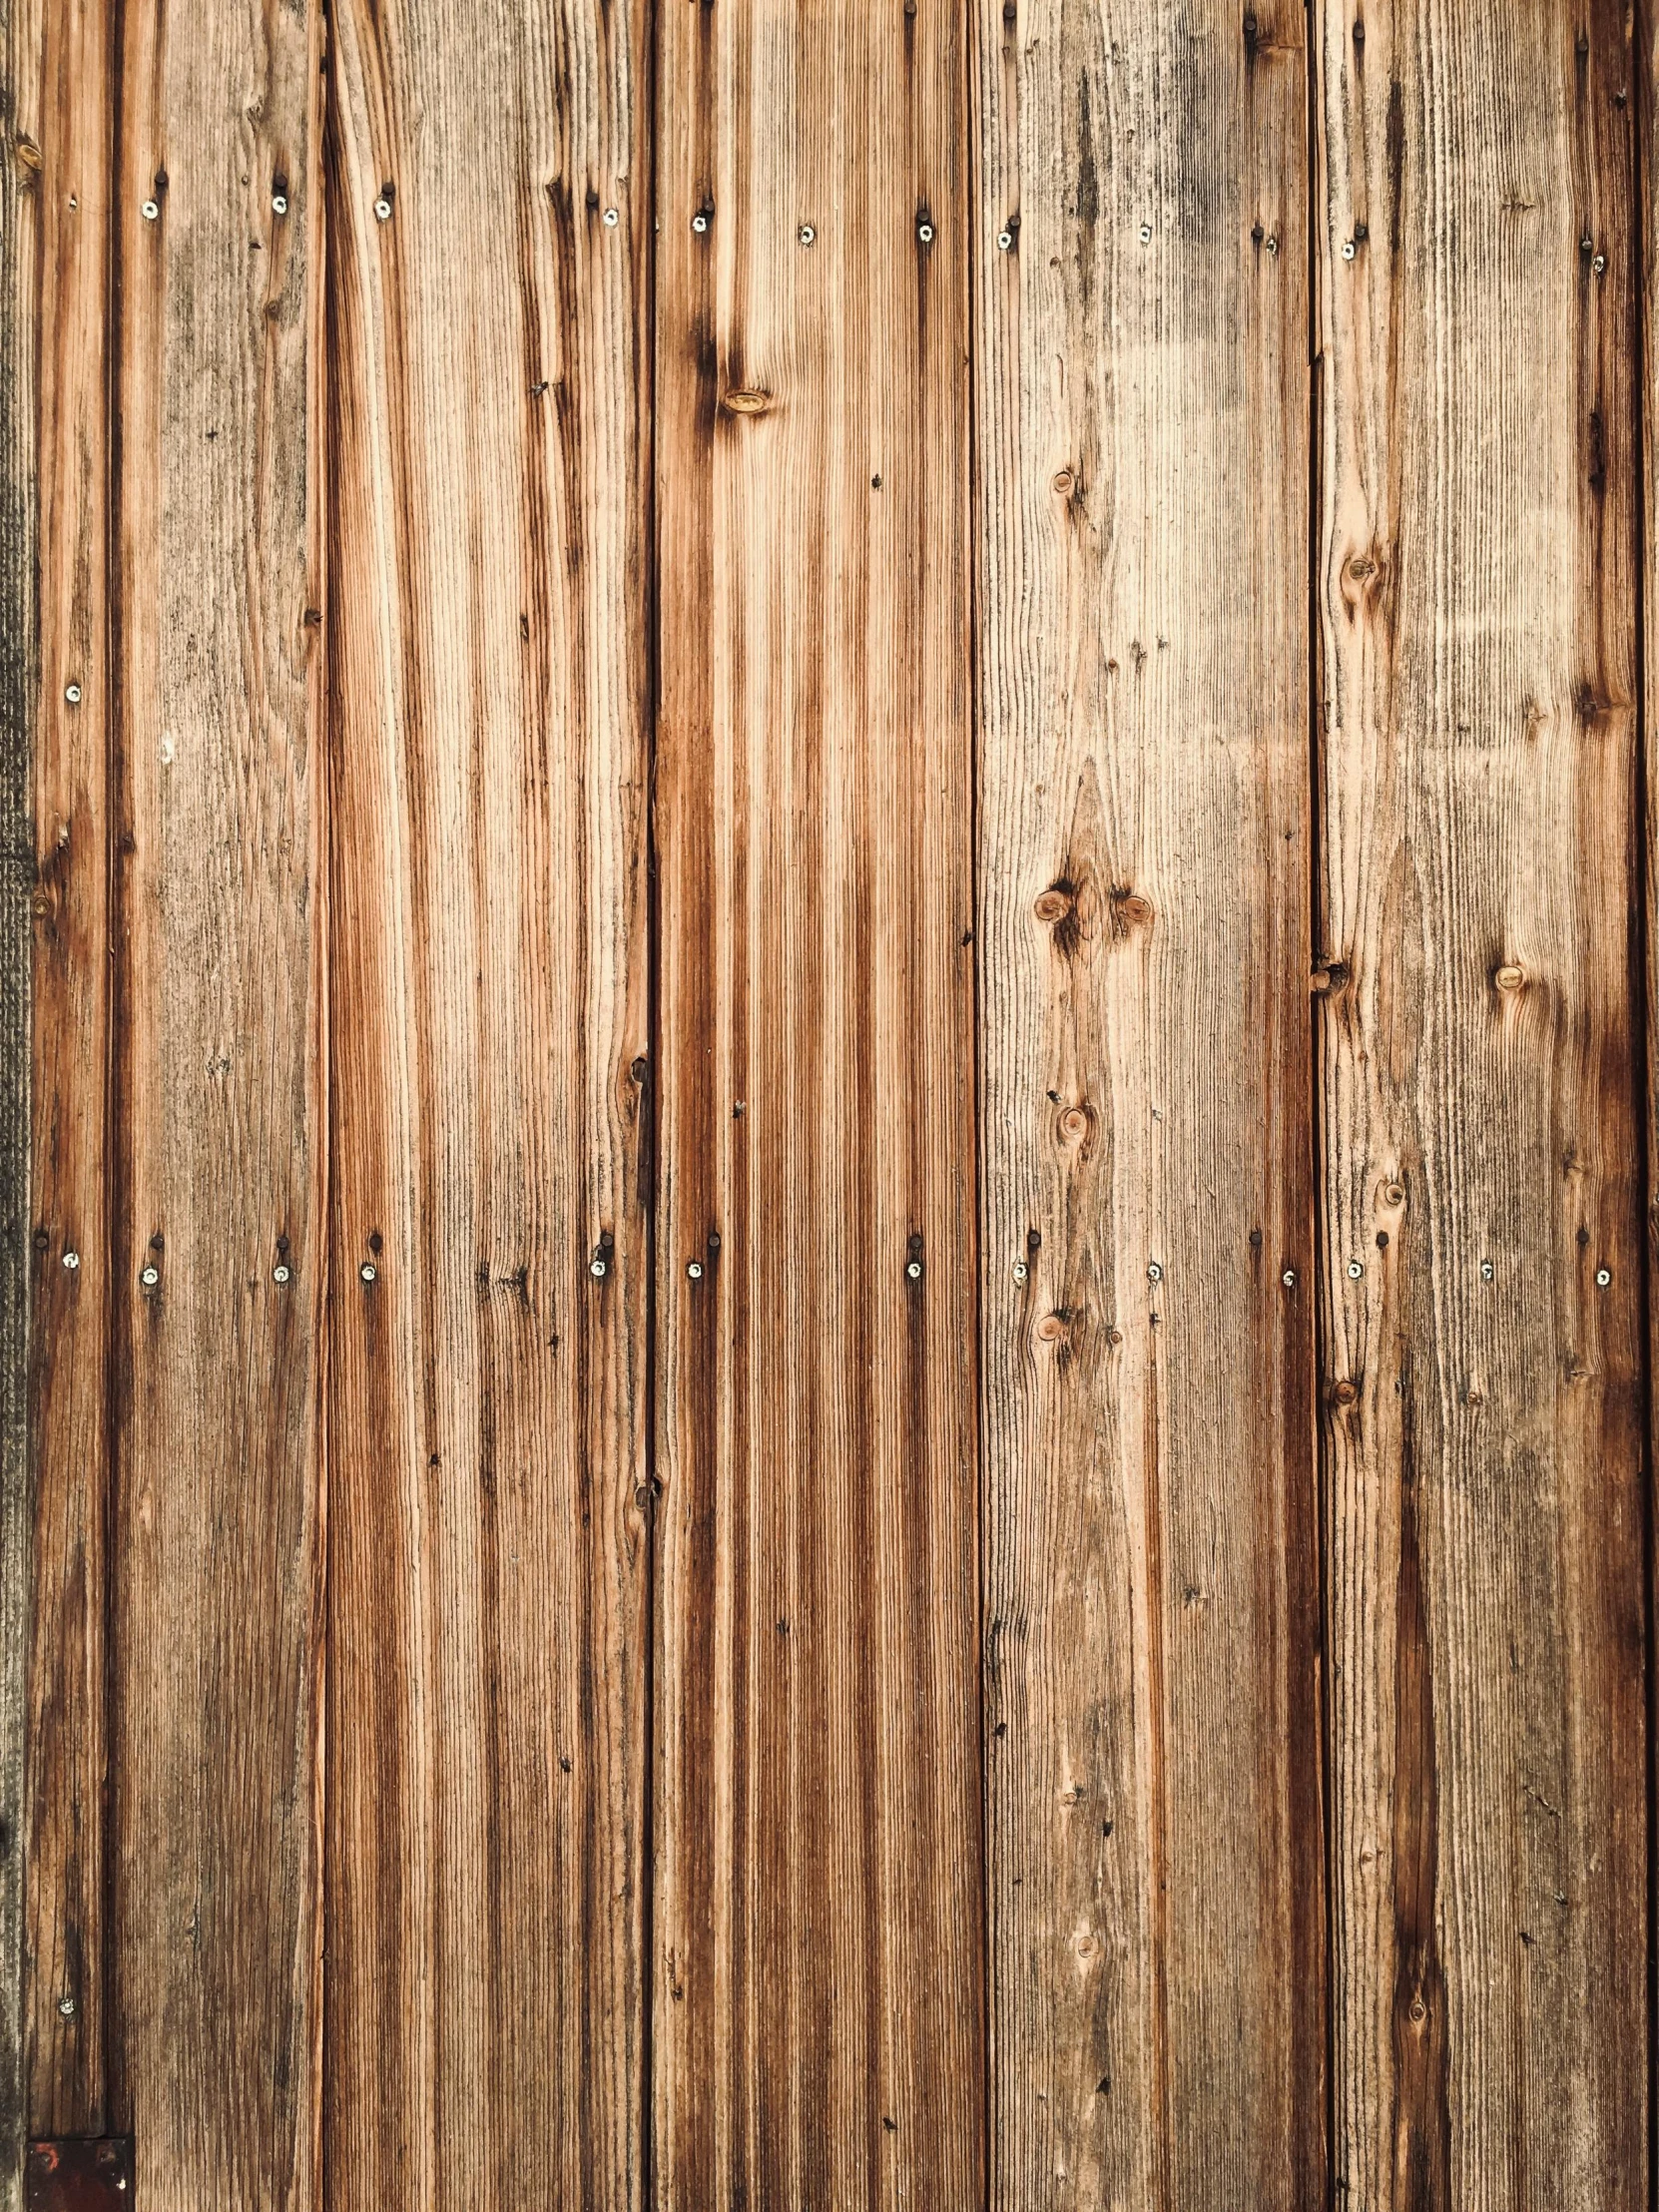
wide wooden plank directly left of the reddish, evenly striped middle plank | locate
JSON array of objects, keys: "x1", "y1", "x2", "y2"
[{"x1": 325, "y1": 0, "x2": 653, "y2": 2212}]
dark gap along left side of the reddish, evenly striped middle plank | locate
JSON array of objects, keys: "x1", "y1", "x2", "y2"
[{"x1": 635, "y1": 0, "x2": 662, "y2": 2212}]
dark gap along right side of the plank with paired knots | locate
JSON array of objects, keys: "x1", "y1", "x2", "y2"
[{"x1": 1288, "y1": 0, "x2": 1339, "y2": 2205}]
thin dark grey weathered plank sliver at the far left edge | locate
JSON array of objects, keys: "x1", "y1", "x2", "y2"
[{"x1": 0, "y1": 0, "x2": 44, "y2": 2185}]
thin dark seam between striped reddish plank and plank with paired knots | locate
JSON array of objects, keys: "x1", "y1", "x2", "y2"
[{"x1": 962, "y1": 0, "x2": 995, "y2": 2212}]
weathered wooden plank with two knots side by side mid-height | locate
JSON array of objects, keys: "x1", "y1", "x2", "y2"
[{"x1": 973, "y1": 0, "x2": 1325, "y2": 2212}]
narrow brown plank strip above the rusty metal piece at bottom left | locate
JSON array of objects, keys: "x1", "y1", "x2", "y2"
[{"x1": 20, "y1": 0, "x2": 113, "y2": 2134}]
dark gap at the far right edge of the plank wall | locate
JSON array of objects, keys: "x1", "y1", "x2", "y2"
[{"x1": 1630, "y1": 0, "x2": 1659, "y2": 2205}]
